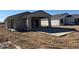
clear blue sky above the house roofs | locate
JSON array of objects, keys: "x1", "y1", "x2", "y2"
[{"x1": 0, "y1": 10, "x2": 79, "y2": 22}]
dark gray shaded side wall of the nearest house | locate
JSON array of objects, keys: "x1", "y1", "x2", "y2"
[{"x1": 5, "y1": 16, "x2": 27, "y2": 31}]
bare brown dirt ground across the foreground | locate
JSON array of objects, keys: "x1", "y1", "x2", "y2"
[{"x1": 0, "y1": 26, "x2": 79, "y2": 49}]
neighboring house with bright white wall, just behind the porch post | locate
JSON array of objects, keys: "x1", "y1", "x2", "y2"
[{"x1": 51, "y1": 13, "x2": 69, "y2": 26}]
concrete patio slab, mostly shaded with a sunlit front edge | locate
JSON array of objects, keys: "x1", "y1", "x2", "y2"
[{"x1": 33, "y1": 27, "x2": 76, "y2": 36}]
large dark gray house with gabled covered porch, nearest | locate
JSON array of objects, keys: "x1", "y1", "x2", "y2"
[{"x1": 5, "y1": 10, "x2": 51, "y2": 31}]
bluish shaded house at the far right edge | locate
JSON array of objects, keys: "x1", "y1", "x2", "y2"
[{"x1": 60, "y1": 14, "x2": 79, "y2": 25}]
